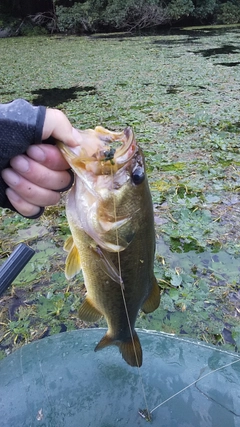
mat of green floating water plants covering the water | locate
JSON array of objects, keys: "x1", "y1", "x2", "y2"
[{"x1": 0, "y1": 28, "x2": 240, "y2": 357}]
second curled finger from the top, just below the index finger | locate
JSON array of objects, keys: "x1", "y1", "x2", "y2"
[{"x1": 7, "y1": 155, "x2": 71, "y2": 190}]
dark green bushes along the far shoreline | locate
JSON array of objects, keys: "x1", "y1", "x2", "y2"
[{"x1": 0, "y1": 0, "x2": 240, "y2": 37}]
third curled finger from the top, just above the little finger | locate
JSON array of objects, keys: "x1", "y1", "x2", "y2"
[{"x1": 2, "y1": 169, "x2": 60, "y2": 207}]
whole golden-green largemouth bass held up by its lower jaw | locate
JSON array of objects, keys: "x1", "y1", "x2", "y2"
[{"x1": 59, "y1": 127, "x2": 160, "y2": 366}]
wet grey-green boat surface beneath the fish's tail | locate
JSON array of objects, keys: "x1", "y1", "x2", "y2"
[{"x1": 0, "y1": 328, "x2": 240, "y2": 427}]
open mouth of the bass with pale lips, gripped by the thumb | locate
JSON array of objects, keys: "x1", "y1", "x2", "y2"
[{"x1": 57, "y1": 126, "x2": 136, "y2": 175}]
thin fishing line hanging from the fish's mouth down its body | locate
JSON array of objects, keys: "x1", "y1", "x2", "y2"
[{"x1": 111, "y1": 167, "x2": 151, "y2": 419}]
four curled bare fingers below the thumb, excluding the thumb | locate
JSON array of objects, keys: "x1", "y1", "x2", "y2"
[{"x1": 2, "y1": 144, "x2": 72, "y2": 218}]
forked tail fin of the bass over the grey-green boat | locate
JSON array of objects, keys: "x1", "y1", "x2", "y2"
[{"x1": 94, "y1": 331, "x2": 142, "y2": 367}]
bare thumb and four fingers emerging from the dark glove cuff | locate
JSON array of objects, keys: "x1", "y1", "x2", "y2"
[{"x1": 2, "y1": 109, "x2": 82, "y2": 218}]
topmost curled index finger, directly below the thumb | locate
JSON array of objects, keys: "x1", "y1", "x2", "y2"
[{"x1": 27, "y1": 144, "x2": 69, "y2": 170}]
